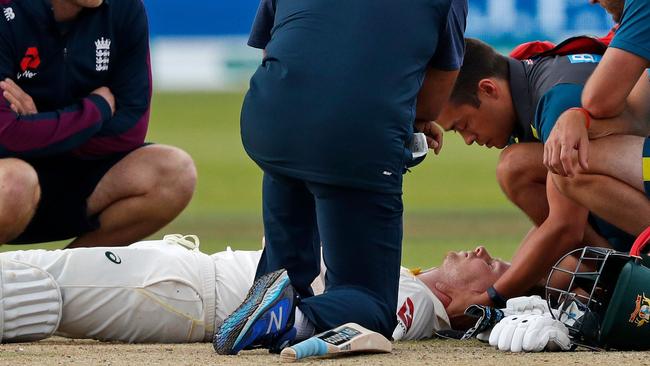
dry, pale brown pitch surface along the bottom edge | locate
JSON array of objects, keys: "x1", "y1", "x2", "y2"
[{"x1": 0, "y1": 337, "x2": 650, "y2": 366}]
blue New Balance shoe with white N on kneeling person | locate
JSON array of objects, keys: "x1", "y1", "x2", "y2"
[{"x1": 213, "y1": 269, "x2": 298, "y2": 355}]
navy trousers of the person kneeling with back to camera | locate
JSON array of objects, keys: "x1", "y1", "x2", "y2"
[{"x1": 257, "y1": 172, "x2": 403, "y2": 339}]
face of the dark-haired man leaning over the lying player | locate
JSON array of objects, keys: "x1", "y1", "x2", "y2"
[{"x1": 436, "y1": 91, "x2": 514, "y2": 149}]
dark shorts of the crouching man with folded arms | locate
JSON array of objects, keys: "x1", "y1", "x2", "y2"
[{"x1": 7, "y1": 152, "x2": 129, "y2": 244}]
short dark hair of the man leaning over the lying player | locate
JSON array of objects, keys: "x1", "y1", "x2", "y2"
[{"x1": 449, "y1": 38, "x2": 509, "y2": 108}]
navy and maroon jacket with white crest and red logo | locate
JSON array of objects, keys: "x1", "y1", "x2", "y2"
[{"x1": 0, "y1": 0, "x2": 151, "y2": 157}]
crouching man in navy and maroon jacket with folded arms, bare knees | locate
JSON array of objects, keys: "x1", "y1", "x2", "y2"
[{"x1": 0, "y1": 0, "x2": 196, "y2": 247}]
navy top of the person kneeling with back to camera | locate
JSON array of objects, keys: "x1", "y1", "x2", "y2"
[{"x1": 241, "y1": 0, "x2": 467, "y2": 193}]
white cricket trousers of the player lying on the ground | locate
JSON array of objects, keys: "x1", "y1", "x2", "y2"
[{"x1": 0, "y1": 240, "x2": 216, "y2": 343}]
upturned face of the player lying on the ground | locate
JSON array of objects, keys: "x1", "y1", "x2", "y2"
[{"x1": 440, "y1": 246, "x2": 510, "y2": 292}]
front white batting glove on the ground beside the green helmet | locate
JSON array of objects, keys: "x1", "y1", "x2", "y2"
[{"x1": 490, "y1": 313, "x2": 571, "y2": 352}]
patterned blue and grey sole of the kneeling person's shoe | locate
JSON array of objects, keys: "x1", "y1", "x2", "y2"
[{"x1": 213, "y1": 270, "x2": 289, "y2": 355}]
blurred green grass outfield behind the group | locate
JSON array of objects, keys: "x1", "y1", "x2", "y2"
[{"x1": 0, "y1": 93, "x2": 530, "y2": 267}]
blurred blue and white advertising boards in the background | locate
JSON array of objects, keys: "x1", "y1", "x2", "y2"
[{"x1": 145, "y1": 0, "x2": 613, "y2": 90}]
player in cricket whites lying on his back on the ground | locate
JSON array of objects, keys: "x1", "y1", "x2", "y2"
[{"x1": 0, "y1": 234, "x2": 509, "y2": 343}]
